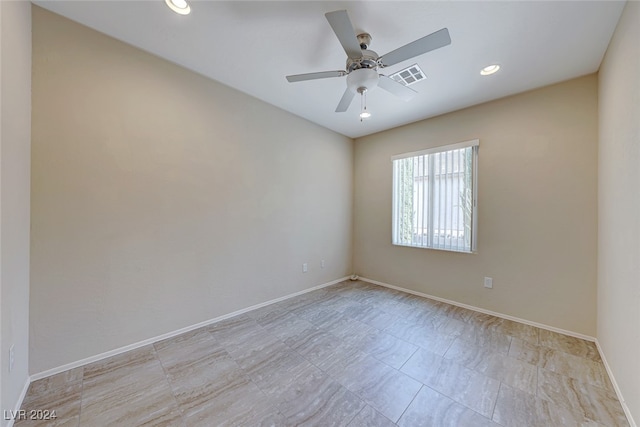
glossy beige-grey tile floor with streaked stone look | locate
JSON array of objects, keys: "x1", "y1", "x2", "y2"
[{"x1": 15, "y1": 282, "x2": 628, "y2": 427}]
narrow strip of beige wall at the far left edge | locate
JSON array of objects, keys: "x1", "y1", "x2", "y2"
[{"x1": 0, "y1": 1, "x2": 31, "y2": 426}]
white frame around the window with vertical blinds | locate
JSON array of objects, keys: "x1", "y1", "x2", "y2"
[{"x1": 391, "y1": 139, "x2": 480, "y2": 253}]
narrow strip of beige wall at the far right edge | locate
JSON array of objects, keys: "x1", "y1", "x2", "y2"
[{"x1": 598, "y1": 1, "x2": 640, "y2": 422}]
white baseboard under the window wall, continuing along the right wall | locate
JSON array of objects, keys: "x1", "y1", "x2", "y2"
[{"x1": 360, "y1": 277, "x2": 638, "y2": 427}]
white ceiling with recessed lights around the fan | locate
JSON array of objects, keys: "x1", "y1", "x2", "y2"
[{"x1": 34, "y1": 0, "x2": 624, "y2": 138}]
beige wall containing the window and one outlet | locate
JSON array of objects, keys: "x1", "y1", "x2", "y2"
[{"x1": 354, "y1": 75, "x2": 598, "y2": 336}]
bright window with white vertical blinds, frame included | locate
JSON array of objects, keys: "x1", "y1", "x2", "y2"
[{"x1": 391, "y1": 140, "x2": 480, "y2": 252}]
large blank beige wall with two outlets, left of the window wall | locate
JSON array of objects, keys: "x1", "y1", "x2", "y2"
[{"x1": 30, "y1": 7, "x2": 353, "y2": 373}]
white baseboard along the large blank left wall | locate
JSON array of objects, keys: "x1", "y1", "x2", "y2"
[{"x1": 27, "y1": 276, "x2": 349, "y2": 386}]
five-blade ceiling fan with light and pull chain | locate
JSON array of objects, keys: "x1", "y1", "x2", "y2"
[{"x1": 287, "y1": 10, "x2": 451, "y2": 117}]
